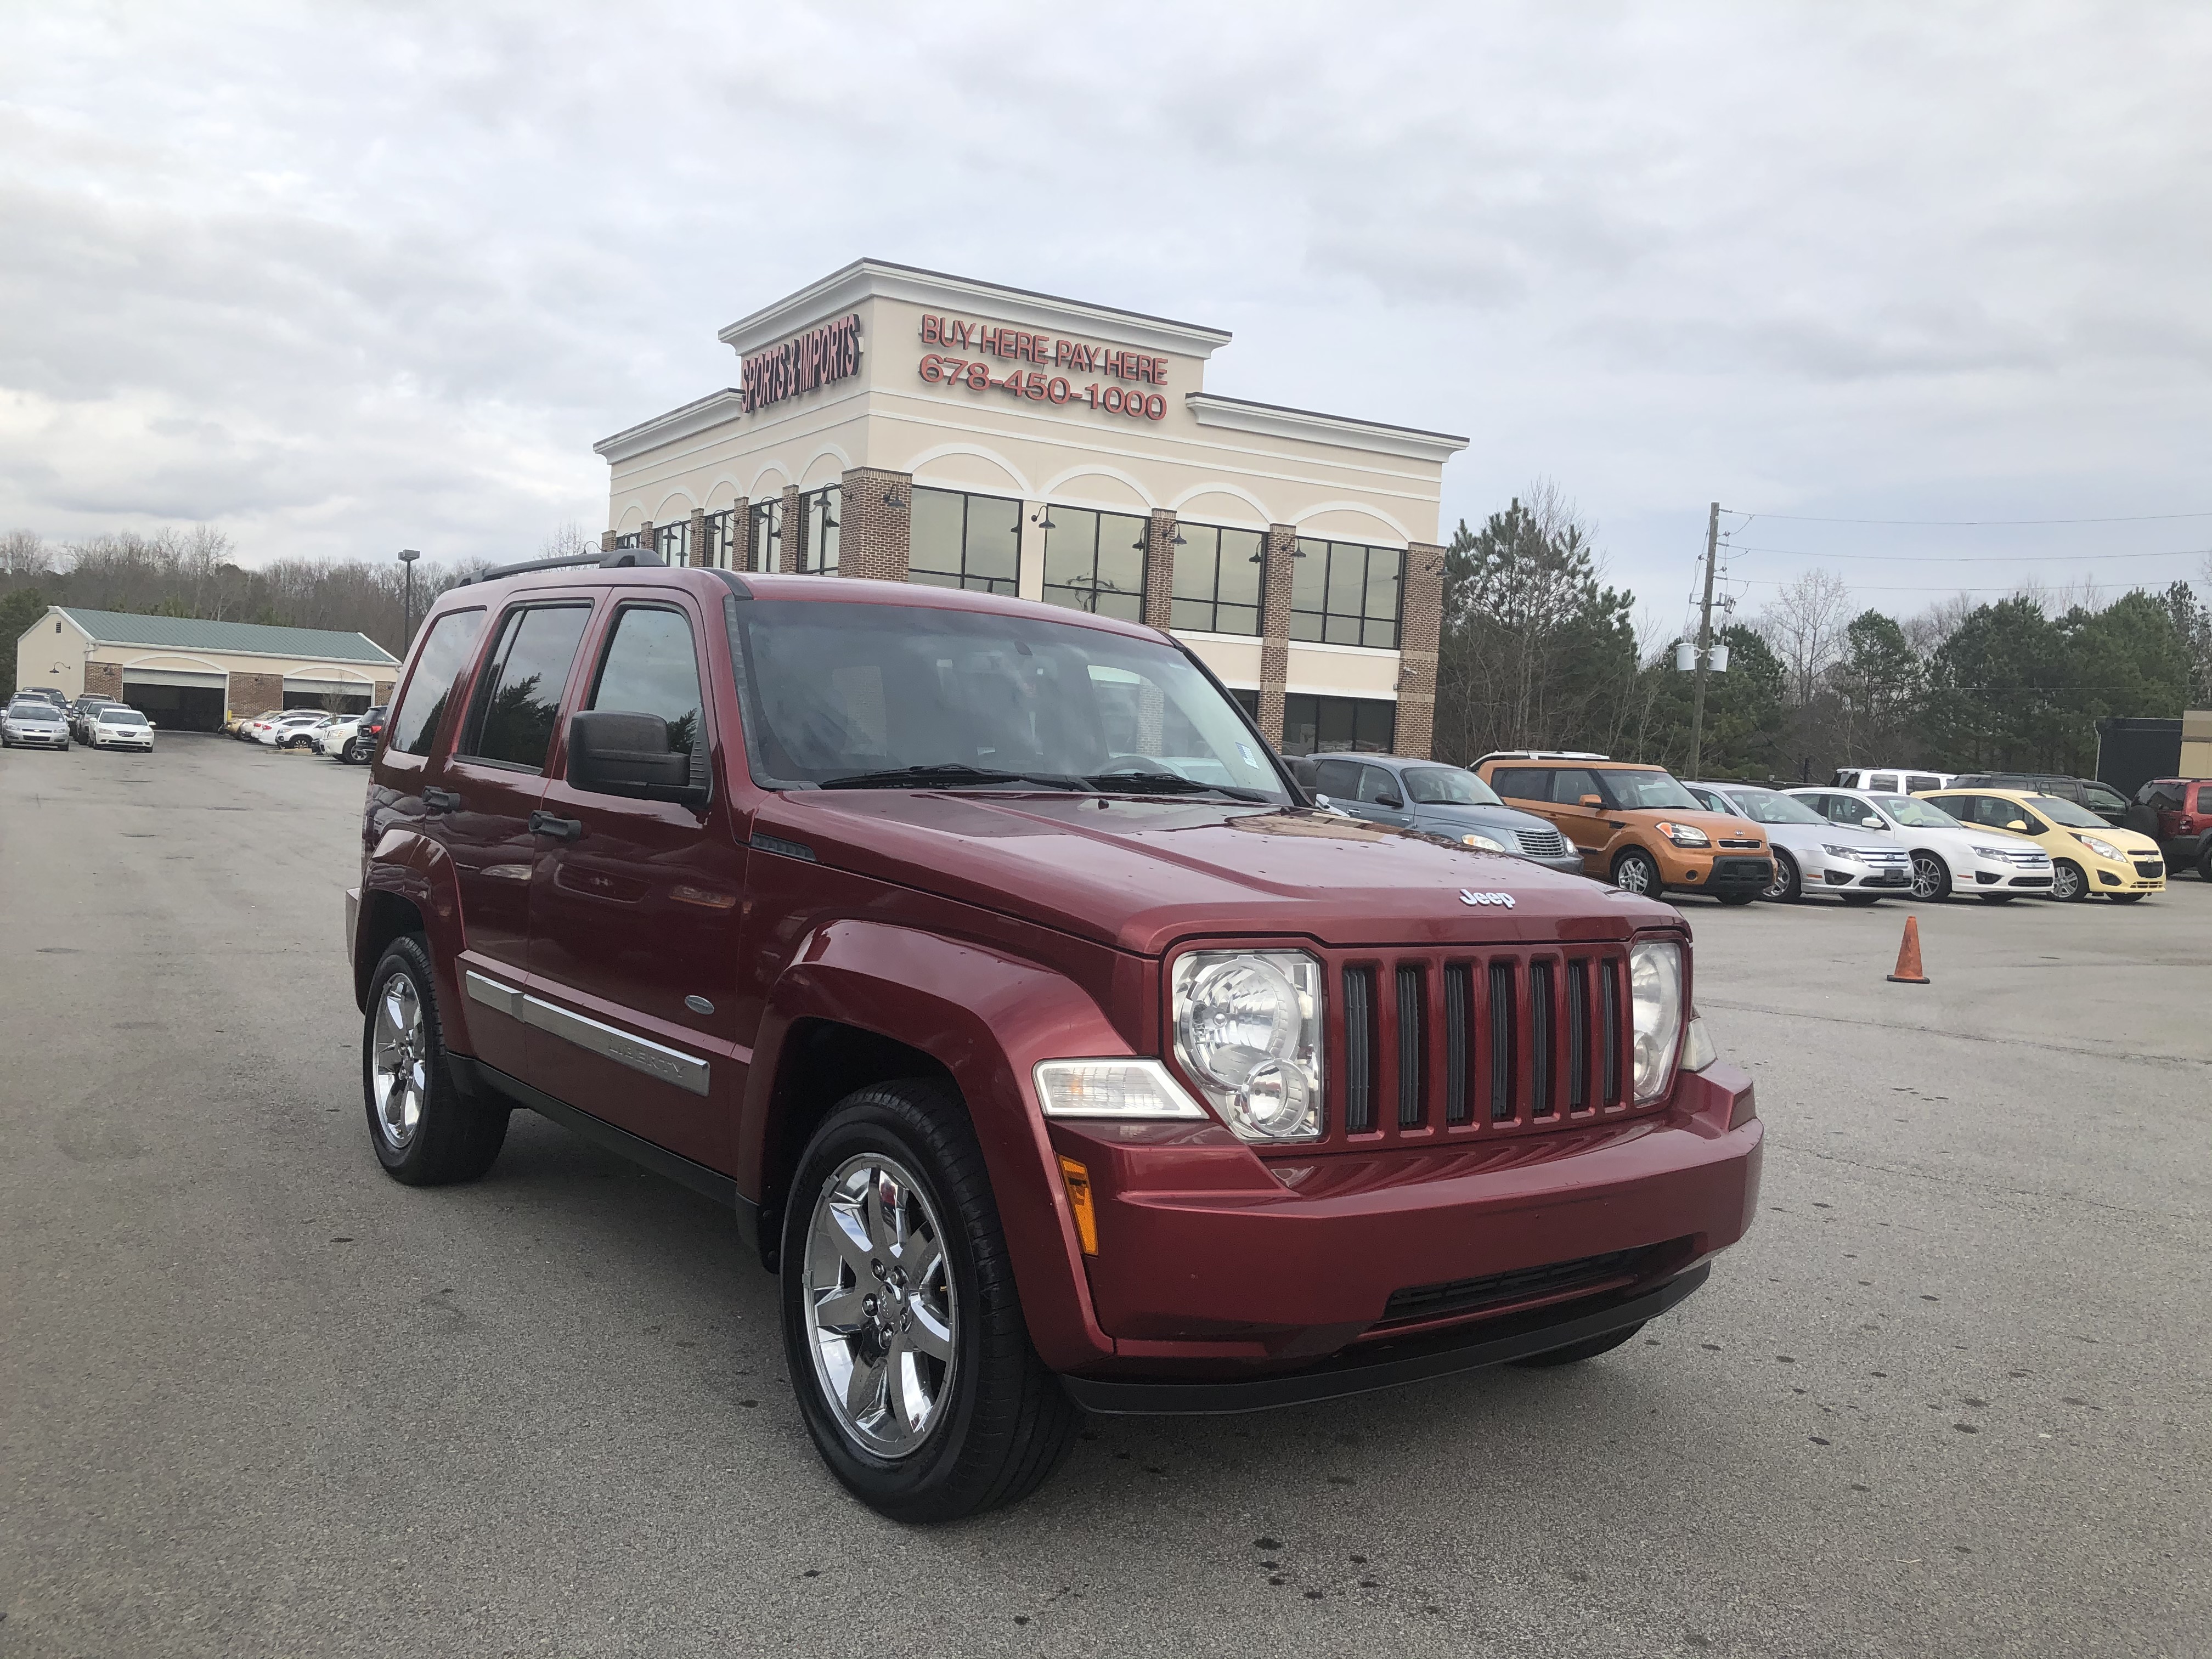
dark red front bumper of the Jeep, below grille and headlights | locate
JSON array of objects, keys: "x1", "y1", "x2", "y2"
[{"x1": 1046, "y1": 1064, "x2": 1763, "y2": 1411}]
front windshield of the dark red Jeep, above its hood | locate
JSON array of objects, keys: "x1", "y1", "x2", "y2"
[{"x1": 730, "y1": 600, "x2": 1290, "y2": 805}]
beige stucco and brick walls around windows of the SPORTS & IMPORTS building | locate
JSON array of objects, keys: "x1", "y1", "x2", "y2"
[{"x1": 595, "y1": 259, "x2": 1464, "y2": 752}]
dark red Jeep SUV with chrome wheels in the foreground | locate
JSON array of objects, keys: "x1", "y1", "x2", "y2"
[{"x1": 347, "y1": 553, "x2": 1760, "y2": 1520}]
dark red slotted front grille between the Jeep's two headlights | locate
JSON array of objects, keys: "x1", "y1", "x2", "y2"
[{"x1": 1325, "y1": 945, "x2": 1633, "y2": 1146}]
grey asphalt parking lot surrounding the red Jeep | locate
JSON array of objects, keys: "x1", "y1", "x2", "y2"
[{"x1": 0, "y1": 735, "x2": 2212, "y2": 1659}]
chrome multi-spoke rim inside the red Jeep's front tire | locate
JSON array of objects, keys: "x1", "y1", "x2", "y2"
[{"x1": 801, "y1": 1153, "x2": 960, "y2": 1458}]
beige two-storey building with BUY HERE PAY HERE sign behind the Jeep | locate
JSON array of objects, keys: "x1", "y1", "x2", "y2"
[{"x1": 593, "y1": 259, "x2": 1466, "y2": 754}]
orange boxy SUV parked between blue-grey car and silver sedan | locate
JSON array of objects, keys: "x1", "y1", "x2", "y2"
[{"x1": 1469, "y1": 750, "x2": 1774, "y2": 905}]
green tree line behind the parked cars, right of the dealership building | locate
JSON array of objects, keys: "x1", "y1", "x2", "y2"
[{"x1": 1436, "y1": 484, "x2": 2212, "y2": 781}]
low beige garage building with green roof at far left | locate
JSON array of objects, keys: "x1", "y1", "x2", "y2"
[{"x1": 15, "y1": 604, "x2": 398, "y2": 732}]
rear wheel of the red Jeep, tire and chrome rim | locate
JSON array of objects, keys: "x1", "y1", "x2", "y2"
[{"x1": 360, "y1": 934, "x2": 511, "y2": 1186}]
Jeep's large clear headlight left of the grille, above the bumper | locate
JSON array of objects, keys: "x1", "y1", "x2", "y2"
[{"x1": 1170, "y1": 951, "x2": 1321, "y2": 1142}]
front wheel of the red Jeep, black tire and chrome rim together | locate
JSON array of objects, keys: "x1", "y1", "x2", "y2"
[{"x1": 781, "y1": 1080, "x2": 1082, "y2": 1522}]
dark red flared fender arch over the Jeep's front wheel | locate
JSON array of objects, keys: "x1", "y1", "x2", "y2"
[{"x1": 737, "y1": 920, "x2": 1128, "y2": 1372}]
